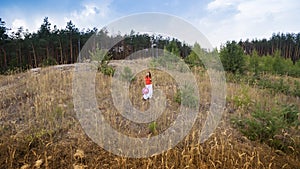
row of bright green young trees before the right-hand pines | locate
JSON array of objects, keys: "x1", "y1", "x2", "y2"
[{"x1": 220, "y1": 41, "x2": 300, "y2": 77}]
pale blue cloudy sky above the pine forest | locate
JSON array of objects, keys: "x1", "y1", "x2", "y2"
[{"x1": 0, "y1": 0, "x2": 300, "y2": 48}]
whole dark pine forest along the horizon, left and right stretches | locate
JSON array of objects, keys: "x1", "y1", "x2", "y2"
[{"x1": 0, "y1": 17, "x2": 300, "y2": 74}]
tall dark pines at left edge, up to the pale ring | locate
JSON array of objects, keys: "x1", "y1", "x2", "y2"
[{"x1": 0, "y1": 17, "x2": 97, "y2": 73}]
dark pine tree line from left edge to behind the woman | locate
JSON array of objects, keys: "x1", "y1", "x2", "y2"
[{"x1": 0, "y1": 17, "x2": 191, "y2": 73}]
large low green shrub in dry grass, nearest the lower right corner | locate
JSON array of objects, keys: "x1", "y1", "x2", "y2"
[{"x1": 232, "y1": 105, "x2": 299, "y2": 152}]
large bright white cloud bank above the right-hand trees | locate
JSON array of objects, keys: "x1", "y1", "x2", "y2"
[{"x1": 195, "y1": 0, "x2": 300, "y2": 47}]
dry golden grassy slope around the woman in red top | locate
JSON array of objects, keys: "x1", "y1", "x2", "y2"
[{"x1": 0, "y1": 64, "x2": 300, "y2": 168}]
